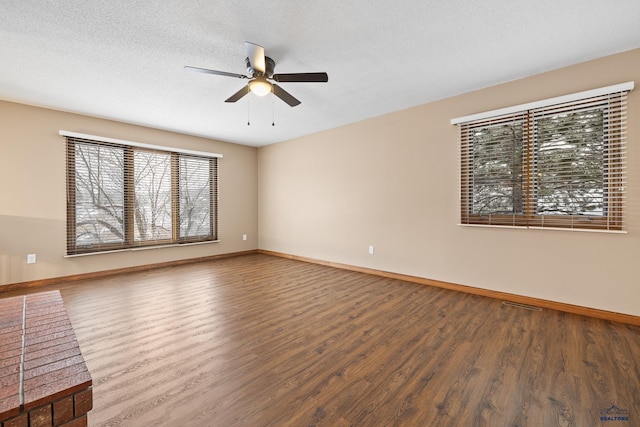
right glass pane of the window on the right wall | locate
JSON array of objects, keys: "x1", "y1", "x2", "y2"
[{"x1": 535, "y1": 108, "x2": 606, "y2": 216}]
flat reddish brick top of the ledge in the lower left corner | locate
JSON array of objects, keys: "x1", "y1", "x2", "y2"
[{"x1": 0, "y1": 291, "x2": 92, "y2": 421}]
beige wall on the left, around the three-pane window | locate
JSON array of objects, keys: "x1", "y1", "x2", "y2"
[{"x1": 0, "y1": 101, "x2": 258, "y2": 286}]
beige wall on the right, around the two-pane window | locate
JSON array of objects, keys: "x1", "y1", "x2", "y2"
[{"x1": 258, "y1": 49, "x2": 640, "y2": 315}]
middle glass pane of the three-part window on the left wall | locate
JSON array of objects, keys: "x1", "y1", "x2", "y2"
[{"x1": 133, "y1": 150, "x2": 172, "y2": 241}]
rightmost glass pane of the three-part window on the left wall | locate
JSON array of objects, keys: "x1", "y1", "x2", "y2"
[{"x1": 179, "y1": 155, "x2": 212, "y2": 238}]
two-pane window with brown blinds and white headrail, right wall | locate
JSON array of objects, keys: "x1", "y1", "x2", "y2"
[{"x1": 451, "y1": 83, "x2": 633, "y2": 230}]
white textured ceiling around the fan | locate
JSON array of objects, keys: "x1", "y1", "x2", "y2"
[{"x1": 0, "y1": 0, "x2": 640, "y2": 146}]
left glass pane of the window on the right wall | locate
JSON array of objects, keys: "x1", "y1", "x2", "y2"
[{"x1": 469, "y1": 121, "x2": 524, "y2": 215}]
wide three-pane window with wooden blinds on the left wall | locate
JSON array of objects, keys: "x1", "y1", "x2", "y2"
[{"x1": 65, "y1": 131, "x2": 221, "y2": 255}]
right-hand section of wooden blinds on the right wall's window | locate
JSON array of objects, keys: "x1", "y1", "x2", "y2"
[{"x1": 529, "y1": 92, "x2": 627, "y2": 230}]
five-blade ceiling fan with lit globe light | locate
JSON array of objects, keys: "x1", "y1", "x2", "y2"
[{"x1": 184, "y1": 42, "x2": 329, "y2": 107}]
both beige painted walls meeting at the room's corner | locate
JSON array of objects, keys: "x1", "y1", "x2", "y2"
[{"x1": 0, "y1": 49, "x2": 640, "y2": 315}]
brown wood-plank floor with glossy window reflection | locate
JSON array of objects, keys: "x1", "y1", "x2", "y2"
[{"x1": 0, "y1": 254, "x2": 640, "y2": 427}]
